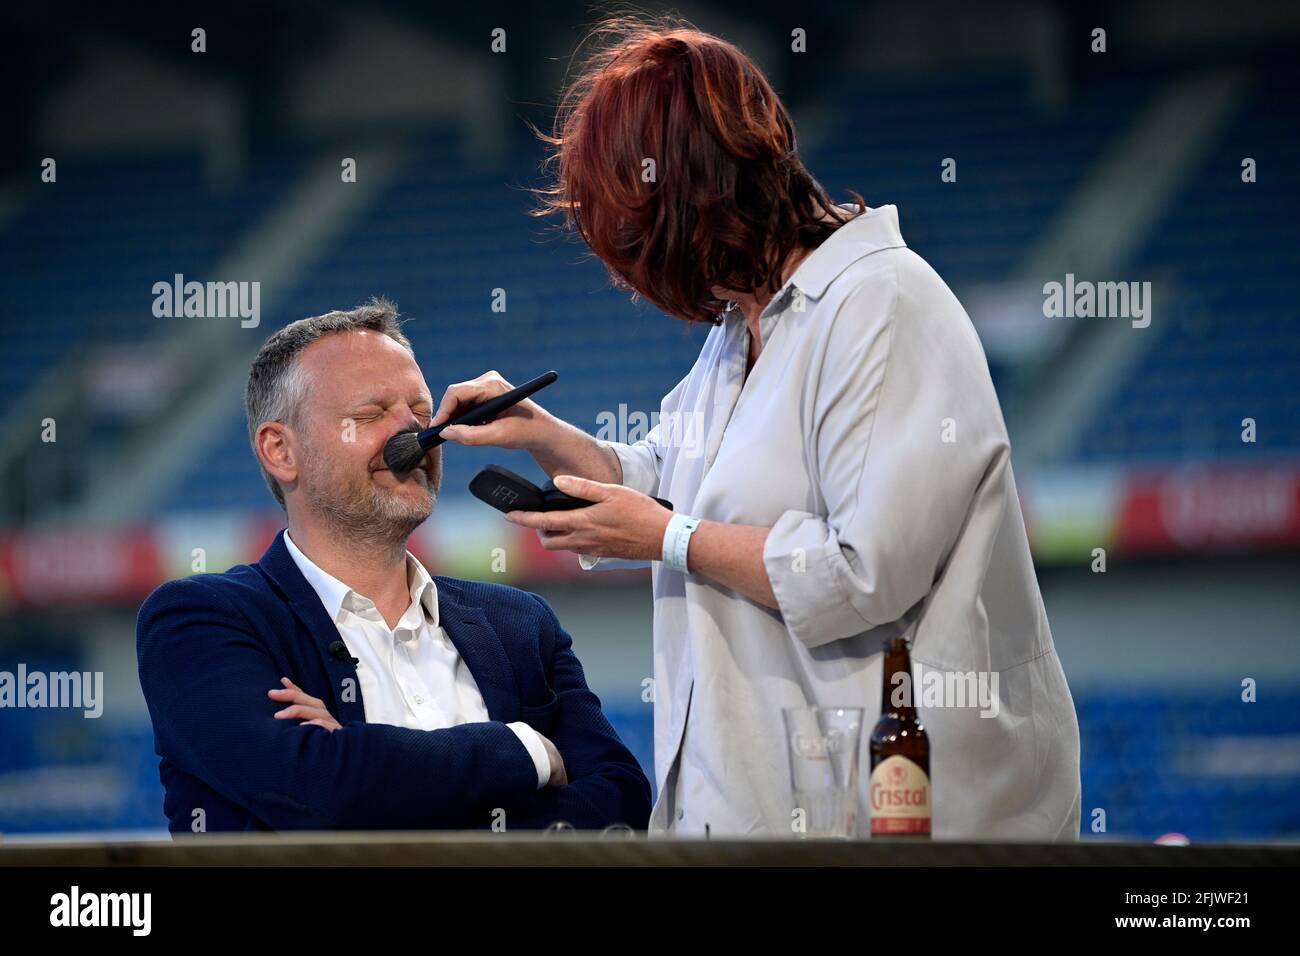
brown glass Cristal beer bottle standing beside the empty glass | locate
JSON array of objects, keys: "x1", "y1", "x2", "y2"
[{"x1": 868, "y1": 637, "x2": 930, "y2": 838}]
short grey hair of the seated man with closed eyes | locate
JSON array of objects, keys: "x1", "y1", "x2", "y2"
[{"x1": 244, "y1": 298, "x2": 415, "y2": 511}]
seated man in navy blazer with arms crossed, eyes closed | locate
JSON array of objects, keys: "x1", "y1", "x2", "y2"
[{"x1": 137, "y1": 299, "x2": 650, "y2": 831}]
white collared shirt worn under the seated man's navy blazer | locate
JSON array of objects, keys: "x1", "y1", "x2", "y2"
[{"x1": 285, "y1": 531, "x2": 551, "y2": 788}]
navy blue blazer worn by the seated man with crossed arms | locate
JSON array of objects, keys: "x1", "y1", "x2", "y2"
[{"x1": 137, "y1": 531, "x2": 650, "y2": 832}]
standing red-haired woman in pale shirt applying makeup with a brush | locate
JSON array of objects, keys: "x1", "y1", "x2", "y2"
[{"x1": 434, "y1": 13, "x2": 1080, "y2": 840}]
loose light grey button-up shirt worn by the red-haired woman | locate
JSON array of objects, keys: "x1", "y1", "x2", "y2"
[{"x1": 582, "y1": 206, "x2": 1080, "y2": 840}]
